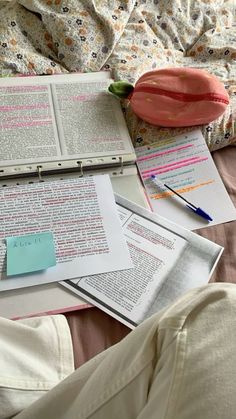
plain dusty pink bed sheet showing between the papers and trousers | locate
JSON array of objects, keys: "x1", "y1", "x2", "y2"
[{"x1": 66, "y1": 146, "x2": 236, "y2": 367}]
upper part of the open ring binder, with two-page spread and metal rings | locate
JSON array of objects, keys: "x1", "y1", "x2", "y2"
[{"x1": 0, "y1": 72, "x2": 147, "y2": 205}]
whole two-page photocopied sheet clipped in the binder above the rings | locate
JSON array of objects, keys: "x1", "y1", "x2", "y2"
[{"x1": 0, "y1": 72, "x2": 135, "y2": 169}]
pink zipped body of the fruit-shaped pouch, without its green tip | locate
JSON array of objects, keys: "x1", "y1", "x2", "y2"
[{"x1": 124, "y1": 67, "x2": 229, "y2": 127}]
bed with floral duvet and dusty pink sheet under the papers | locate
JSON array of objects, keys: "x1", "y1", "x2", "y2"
[{"x1": 0, "y1": 0, "x2": 236, "y2": 366}]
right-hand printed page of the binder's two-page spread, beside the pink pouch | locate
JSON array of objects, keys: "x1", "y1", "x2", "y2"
[{"x1": 52, "y1": 80, "x2": 133, "y2": 158}]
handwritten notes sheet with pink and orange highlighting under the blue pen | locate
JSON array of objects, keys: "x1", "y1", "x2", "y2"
[{"x1": 136, "y1": 130, "x2": 236, "y2": 230}]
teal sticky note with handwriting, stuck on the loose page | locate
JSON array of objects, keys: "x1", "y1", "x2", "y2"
[{"x1": 6, "y1": 232, "x2": 56, "y2": 276}]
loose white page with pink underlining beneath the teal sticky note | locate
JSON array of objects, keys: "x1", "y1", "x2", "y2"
[{"x1": 0, "y1": 175, "x2": 133, "y2": 291}]
